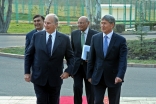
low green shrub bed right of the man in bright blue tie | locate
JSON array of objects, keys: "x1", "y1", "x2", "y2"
[{"x1": 127, "y1": 39, "x2": 156, "y2": 60}]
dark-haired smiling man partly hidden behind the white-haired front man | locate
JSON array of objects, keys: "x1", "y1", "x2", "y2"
[{"x1": 25, "y1": 15, "x2": 44, "y2": 51}]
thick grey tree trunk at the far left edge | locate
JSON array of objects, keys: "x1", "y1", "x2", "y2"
[{"x1": 0, "y1": 0, "x2": 13, "y2": 33}]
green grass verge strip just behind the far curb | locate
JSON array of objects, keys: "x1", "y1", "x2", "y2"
[{"x1": 0, "y1": 47, "x2": 156, "y2": 64}]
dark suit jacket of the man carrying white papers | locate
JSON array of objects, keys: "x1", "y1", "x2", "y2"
[{"x1": 71, "y1": 29, "x2": 98, "y2": 75}]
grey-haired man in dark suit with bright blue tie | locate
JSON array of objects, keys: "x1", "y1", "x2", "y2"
[{"x1": 87, "y1": 15, "x2": 127, "y2": 104}]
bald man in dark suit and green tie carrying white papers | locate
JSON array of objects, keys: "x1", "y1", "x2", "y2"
[{"x1": 71, "y1": 16, "x2": 98, "y2": 104}]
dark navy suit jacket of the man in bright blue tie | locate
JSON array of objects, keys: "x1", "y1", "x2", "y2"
[{"x1": 87, "y1": 33, "x2": 127, "y2": 87}]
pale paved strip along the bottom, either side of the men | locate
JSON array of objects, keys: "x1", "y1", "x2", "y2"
[{"x1": 0, "y1": 96, "x2": 156, "y2": 104}]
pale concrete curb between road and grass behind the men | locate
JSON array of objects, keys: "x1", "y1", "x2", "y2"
[{"x1": 0, "y1": 52, "x2": 156, "y2": 68}]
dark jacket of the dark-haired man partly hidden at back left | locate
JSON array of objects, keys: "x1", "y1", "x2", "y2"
[{"x1": 25, "y1": 29, "x2": 37, "y2": 53}]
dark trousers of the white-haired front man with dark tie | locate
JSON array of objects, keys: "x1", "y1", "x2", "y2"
[{"x1": 34, "y1": 83, "x2": 61, "y2": 104}]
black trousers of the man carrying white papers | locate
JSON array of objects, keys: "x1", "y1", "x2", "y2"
[{"x1": 73, "y1": 62, "x2": 94, "y2": 104}]
